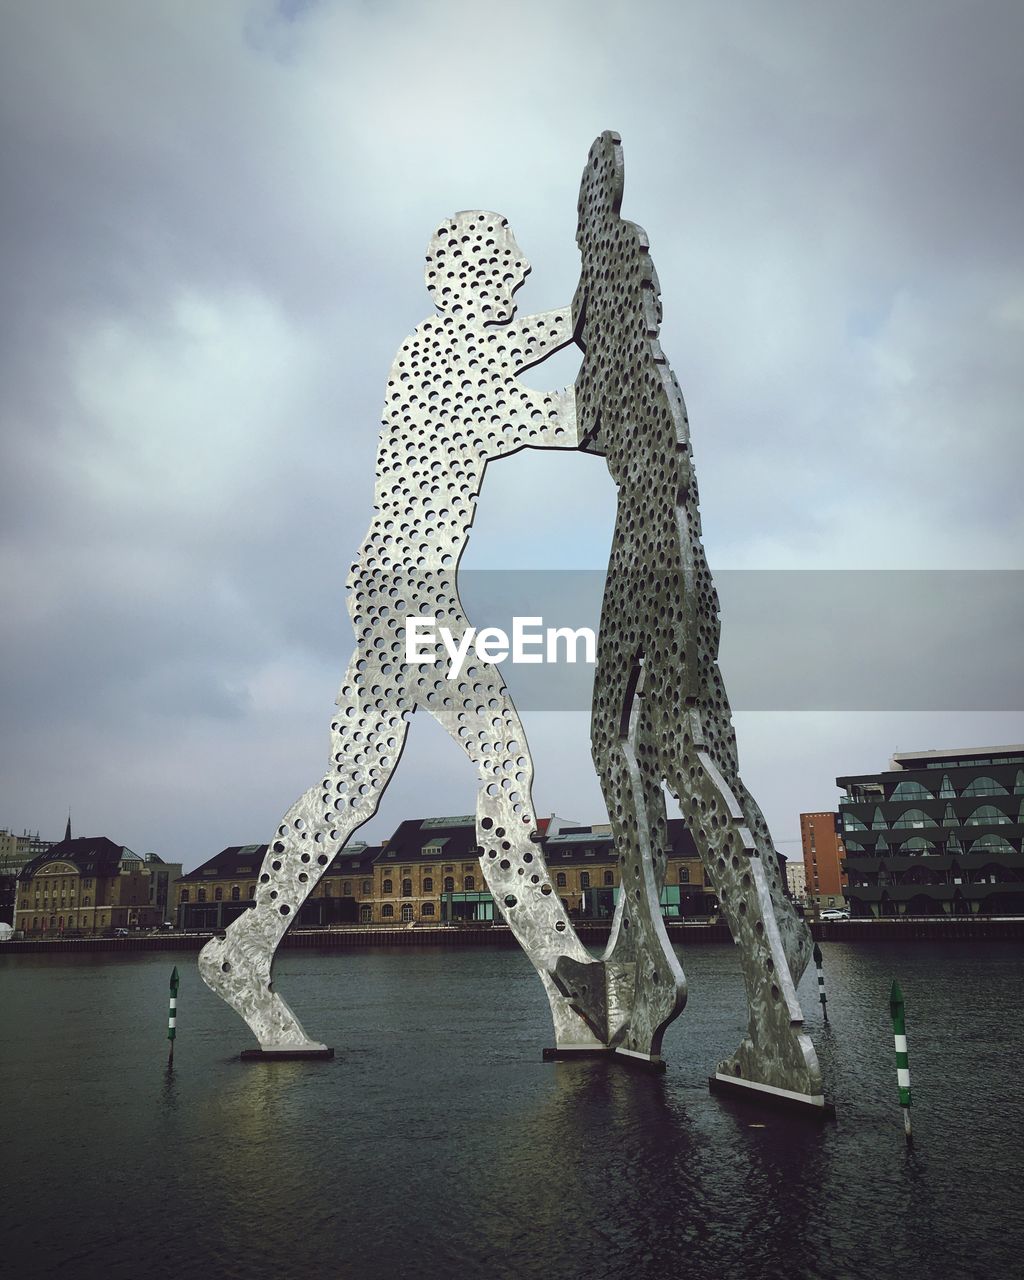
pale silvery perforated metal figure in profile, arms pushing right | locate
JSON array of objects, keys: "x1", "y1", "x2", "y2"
[{"x1": 200, "y1": 210, "x2": 609, "y2": 1055}]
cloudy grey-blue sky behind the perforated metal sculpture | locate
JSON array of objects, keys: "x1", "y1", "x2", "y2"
[{"x1": 0, "y1": 0, "x2": 1024, "y2": 865}]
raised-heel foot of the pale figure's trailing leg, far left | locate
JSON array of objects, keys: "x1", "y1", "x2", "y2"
[{"x1": 200, "y1": 916, "x2": 326, "y2": 1053}]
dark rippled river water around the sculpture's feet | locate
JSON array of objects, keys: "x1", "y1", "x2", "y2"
[{"x1": 0, "y1": 942, "x2": 1024, "y2": 1280}]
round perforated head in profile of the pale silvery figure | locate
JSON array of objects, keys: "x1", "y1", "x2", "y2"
[{"x1": 425, "y1": 209, "x2": 530, "y2": 324}]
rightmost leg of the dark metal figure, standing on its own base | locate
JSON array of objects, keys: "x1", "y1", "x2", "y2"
[{"x1": 668, "y1": 749, "x2": 823, "y2": 1105}]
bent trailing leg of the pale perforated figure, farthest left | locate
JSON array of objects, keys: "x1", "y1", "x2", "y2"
[{"x1": 200, "y1": 657, "x2": 408, "y2": 1052}]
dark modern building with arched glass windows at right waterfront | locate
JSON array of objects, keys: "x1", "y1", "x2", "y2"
[{"x1": 836, "y1": 746, "x2": 1024, "y2": 916}]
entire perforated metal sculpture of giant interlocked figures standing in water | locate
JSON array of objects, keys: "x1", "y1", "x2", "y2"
[{"x1": 200, "y1": 133, "x2": 823, "y2": 1106}]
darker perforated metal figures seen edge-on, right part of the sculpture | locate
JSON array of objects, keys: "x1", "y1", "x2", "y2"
[{"x1": 561, "y1": 133, "x2": 823, "y2": 1103}]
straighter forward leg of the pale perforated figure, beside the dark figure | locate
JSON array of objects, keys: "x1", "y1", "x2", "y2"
[{"x1": 421, "y1": 666, "x2": 607, "y2": 1052}]
